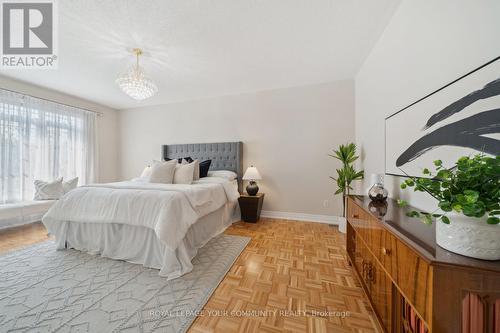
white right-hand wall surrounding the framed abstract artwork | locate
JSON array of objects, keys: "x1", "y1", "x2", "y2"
[{"x1": 355, "y1": 0, "x2": 500, "y2": 208}]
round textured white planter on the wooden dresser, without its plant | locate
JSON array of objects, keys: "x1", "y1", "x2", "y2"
[{"x1": 435, "y1": 214, "x2": 500, "y2": 260}]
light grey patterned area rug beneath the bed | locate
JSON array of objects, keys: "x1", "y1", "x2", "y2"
[{"x1": 0, "y1": 235, "x2": 250, "y2": 332}]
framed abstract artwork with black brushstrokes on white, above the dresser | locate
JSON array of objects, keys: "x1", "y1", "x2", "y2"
[{"x1": 385, "y1": 57, "x2": 500, "y2": 177}]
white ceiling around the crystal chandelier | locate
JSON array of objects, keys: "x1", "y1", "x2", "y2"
[{"x1": 2, "y1": 0, "x2": 400, "y2": 109}]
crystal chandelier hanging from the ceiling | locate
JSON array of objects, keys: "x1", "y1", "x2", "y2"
[{"x1": 116, "y1": 49, "x2": 158, "y2": 101}]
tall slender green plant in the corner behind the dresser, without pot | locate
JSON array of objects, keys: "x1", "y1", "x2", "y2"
[{"x1": 329, "y1": 143, "x2": 364, "y2": 217}]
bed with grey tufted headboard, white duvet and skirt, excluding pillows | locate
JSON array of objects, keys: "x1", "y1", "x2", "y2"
[{"x1": 42, "y1": 142, "x2": 243, "y2": 280}]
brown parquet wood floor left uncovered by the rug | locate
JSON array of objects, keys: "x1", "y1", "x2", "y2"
[{"x1": 0, "y1": 219, "x2": 377, "y2": 333}]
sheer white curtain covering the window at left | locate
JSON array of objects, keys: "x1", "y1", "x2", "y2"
[{"x1": 0, "y1": 89, "x2": 97, "y2": 204}]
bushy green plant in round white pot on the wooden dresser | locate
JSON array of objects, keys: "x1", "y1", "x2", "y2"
[{"x1": 400, "y1": 154, "x2": 500, "y2": 260}]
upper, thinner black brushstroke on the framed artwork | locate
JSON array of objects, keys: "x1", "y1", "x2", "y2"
[{"x1": 424, "y1": 78, "x2": 500, "y2": 130}]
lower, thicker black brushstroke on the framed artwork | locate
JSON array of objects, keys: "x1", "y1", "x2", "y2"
[{"x1": 396, "y1": 108, "x2": 500, "y2": 167}]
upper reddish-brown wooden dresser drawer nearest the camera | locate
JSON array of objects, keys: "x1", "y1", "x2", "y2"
[{"x1": 391, "y1": 236, "x2": 432, "y2": 322}]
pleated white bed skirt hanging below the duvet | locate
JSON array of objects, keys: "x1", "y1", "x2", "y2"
[{"x1": 47, "y1": 203, "x2": 239, "y2": 280}]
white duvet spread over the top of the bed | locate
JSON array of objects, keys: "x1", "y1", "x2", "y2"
[{"x1": 42, "y1": 177, "x2": 238, "y2": 250}]
